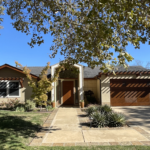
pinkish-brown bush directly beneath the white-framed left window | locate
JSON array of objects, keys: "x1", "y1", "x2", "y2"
[{"x1": 4, "y1": 98, "x2": 19, "y2": 110}]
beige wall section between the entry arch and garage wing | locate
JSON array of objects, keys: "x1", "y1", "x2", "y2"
[{"x1": 83, "y1": 79, "x2": 98, "y2": 100}]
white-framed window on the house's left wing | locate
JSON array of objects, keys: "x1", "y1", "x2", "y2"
[{"x1": 0, "y1": 81, "x2": 20, "y2": 97}]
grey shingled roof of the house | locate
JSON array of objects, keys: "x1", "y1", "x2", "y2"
[{"x1": 0, "y1": 64, "x2": 150, "y2": 78}]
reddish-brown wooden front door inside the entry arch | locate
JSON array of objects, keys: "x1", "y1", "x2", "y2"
[{"x1": 63, "y1": 81, "x2": 74, "y2": 105}]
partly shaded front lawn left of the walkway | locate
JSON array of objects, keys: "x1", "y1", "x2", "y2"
[{"x1": 0, "y1": 110, "x2": 49, "y2": 150}]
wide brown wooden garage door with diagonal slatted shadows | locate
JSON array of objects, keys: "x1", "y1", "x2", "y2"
[{"x1": 110, "y1": 79, "x2": 150, "y2": 106}]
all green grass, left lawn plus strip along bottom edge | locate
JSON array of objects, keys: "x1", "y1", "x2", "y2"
[{"x1": 0, "y1": 110, "x2": 150, "y2": 150}]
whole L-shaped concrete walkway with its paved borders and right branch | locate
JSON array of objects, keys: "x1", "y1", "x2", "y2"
[{"x1": 30, "y1": 108, "x2": 150, "y2": 146}]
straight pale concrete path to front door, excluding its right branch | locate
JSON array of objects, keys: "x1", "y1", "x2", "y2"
[{"x1": 43, "y1": 108, "x2": 84, "y2": 143}]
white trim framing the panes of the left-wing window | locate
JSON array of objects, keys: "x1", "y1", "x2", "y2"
[{"x1": 0, "y1": 80, "x2": 21, "y2": 98}]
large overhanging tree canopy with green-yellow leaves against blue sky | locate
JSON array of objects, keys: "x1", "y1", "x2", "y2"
[{"x1": 3, "y1": 0, "x2": 150, "y2": 71}]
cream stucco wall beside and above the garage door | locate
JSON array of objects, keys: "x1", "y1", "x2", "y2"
[{"x1": 101, "y1": 75, "x2": 150, "y2": 105}]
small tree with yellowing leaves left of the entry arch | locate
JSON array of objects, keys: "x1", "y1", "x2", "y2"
[{"x1": 15, "y1": 62, "x2": 63, "y2": 109}]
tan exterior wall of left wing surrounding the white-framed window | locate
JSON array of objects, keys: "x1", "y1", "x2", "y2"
[{"x1": 0, "y1": 68, "x2": 35, "y2": 103}]
